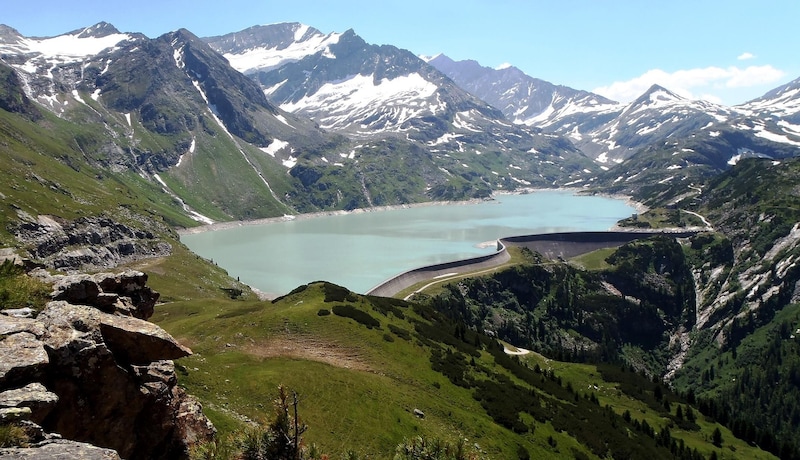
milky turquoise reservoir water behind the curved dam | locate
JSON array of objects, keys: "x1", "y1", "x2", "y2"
[{"x1": 181, "y1": 191, "x2": 635, "y2": 295}]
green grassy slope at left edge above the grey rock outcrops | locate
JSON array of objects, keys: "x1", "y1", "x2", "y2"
[{"x1": 0, "y1": 111, "x2": 194, "y2": 237}]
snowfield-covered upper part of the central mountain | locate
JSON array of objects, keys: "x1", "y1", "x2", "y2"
[{"x1": 207, "y1": 24, "x2": 502, "y2": 137}]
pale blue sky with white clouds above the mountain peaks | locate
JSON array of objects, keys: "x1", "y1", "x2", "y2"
[{"x1": 0, "y1": 0, "x2": 800, "y2": 105}]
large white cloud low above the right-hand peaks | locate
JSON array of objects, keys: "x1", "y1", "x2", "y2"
[{"x1": 592, "y1": 65, "x2": 785, "y2": 102}]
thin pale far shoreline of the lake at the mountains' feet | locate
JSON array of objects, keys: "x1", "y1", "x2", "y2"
[{"x1": 176, "y1": 188, "x2": 648, "y2": 235}]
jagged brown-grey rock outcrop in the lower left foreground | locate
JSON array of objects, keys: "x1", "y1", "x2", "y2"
[{"x1": 0, "y1": 271, "x2": 215, "y2": 459}]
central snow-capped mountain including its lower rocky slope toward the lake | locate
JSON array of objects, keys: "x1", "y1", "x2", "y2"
[{"x1": 206, "y1": 24, "x2": 594, "y2": 188}]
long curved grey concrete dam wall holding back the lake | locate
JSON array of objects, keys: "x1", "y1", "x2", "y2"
[{"x1": 367, "y1": 229, "x2": 700, "y2": 297}]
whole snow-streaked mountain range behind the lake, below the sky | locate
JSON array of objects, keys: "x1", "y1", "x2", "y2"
[{"x1": 0, "y1": 23, "x2": 800, "y2": 222}]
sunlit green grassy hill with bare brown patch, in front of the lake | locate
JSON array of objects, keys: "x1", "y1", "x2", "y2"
[{"x1": 153, "y1": 278, "x2": 771, "y2": 458}]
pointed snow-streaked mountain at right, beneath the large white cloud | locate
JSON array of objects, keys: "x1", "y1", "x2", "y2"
[{"x1": 591, "y1": 86, "x2": 800, "y2": 200}]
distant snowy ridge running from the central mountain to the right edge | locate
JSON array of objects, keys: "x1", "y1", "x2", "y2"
[{"x1": 428, "y1": 51, "x2": 800, "y2": 172}]
